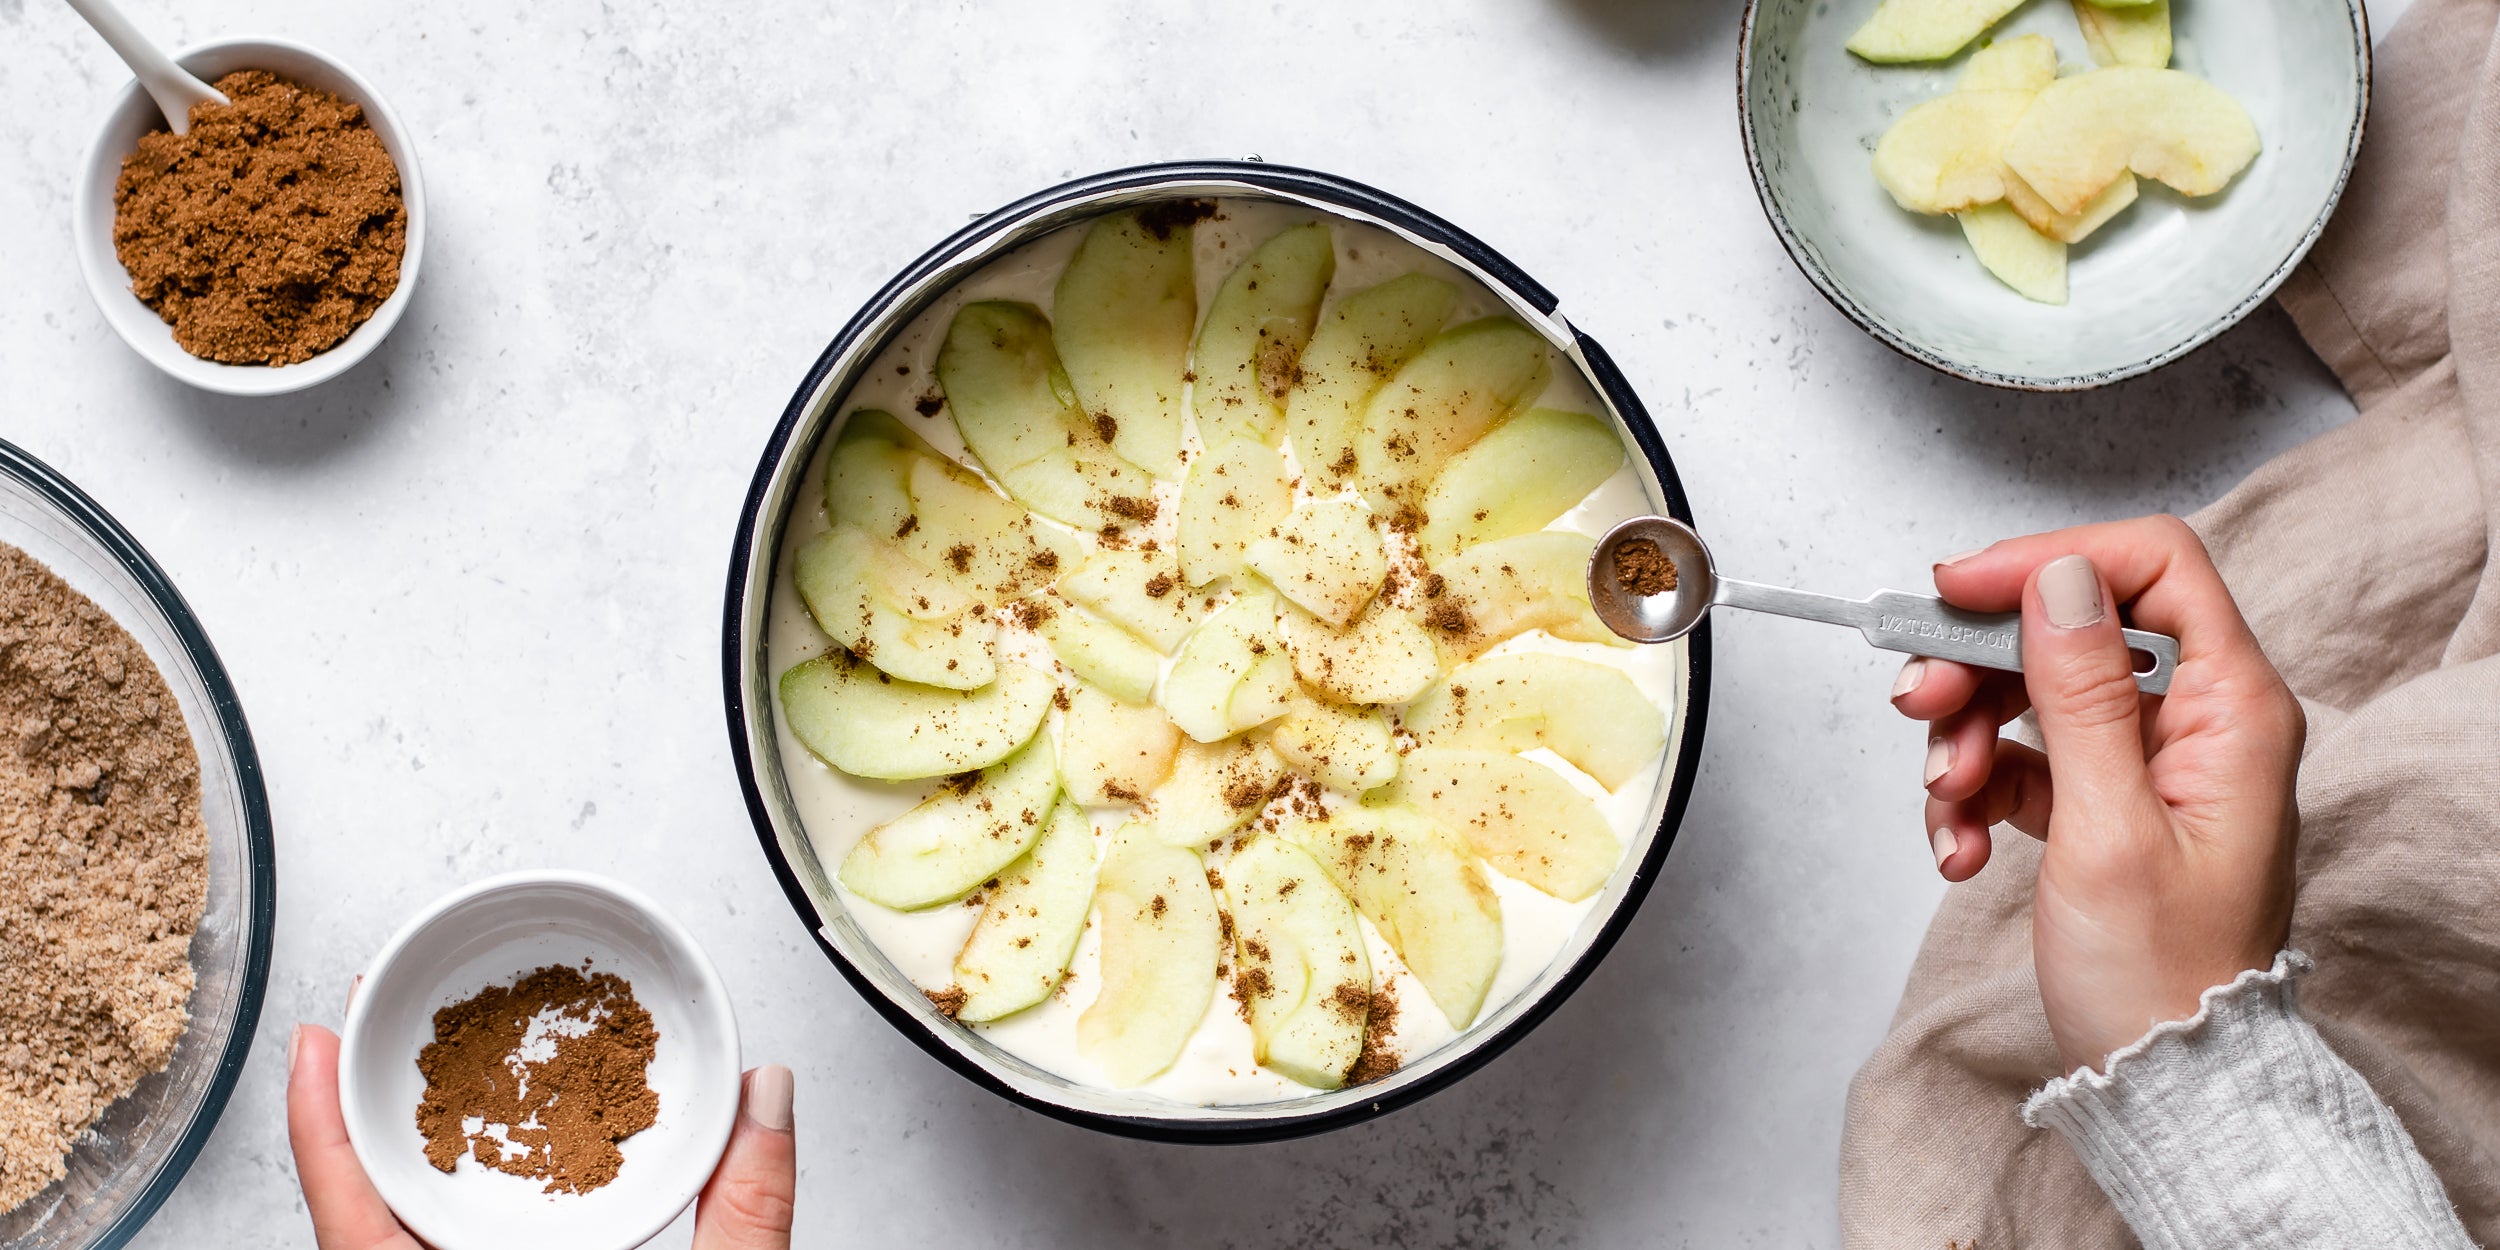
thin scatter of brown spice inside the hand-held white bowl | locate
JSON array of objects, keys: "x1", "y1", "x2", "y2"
[{"x1": 418, "y1": 965, "x2": 660, "y2": 1193}]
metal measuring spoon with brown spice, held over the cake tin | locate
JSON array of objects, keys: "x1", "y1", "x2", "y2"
[{"x1": 1588, "y1": 518, "x2": 2180, "y2": 695}]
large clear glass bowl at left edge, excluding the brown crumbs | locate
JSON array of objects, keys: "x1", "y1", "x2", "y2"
[{"x1": 0, "y1": 443, "x2": 278, "y2": 1250}]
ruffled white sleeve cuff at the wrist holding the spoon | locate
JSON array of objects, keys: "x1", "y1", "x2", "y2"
[{"x1": 2023, "y1": 950, "x2": 2473, "y2": 1250}]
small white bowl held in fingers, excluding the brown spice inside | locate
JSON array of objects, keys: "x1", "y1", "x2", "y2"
[{"x1": 338, "y1": 873, "x2": 740, "y2": 1250}]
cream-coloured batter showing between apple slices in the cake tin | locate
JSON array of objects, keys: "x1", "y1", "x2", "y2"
[{"x1": 765, "y1": 200, "x2": 1680, "y2": 1105}]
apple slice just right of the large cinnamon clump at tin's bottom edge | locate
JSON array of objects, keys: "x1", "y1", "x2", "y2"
[{"x1": 1285, "y1": 803, "x2": 1503, "y2": 1028}]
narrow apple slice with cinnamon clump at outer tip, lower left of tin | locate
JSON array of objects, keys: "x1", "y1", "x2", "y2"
[{"x1": 955, "y1": 800, "x2": 1095, "y2": 1025}]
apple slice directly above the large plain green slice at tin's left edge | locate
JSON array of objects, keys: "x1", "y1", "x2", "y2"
[{"x1": 790, "y1": 525, "x2": 998, "y2": 690}]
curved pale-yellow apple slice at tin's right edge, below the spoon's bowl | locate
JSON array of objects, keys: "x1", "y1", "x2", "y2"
[{"x1": 1405, "y1": 653, "x2": 1668, "y2": 790}]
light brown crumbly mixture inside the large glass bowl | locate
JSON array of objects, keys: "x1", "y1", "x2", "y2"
[{"x1": 0, "y1": 545, "x2": 208, "y2": 1213}]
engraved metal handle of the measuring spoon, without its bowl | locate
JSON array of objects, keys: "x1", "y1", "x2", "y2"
[{"x1": 1710, "y1": 578, "x2": 2180, "y2": 695}]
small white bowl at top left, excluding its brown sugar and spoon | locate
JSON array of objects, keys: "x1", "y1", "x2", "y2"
[{"x1": 70, "y1": 38, "x2": 425, "y2": 395}]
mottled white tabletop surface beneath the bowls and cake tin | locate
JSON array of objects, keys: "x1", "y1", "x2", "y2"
[{"x1": 0, "y1": 0, "x2": 2388, "y2": 1248}]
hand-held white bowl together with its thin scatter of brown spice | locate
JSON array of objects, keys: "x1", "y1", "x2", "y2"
[{"x1": 338, "y1": 870, "x2": 740, "y2": 1250}]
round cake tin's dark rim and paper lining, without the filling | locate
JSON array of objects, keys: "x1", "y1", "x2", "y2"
[{"x1": 720, "y1": 160, "x2": 1710, "y2": 1143}]
